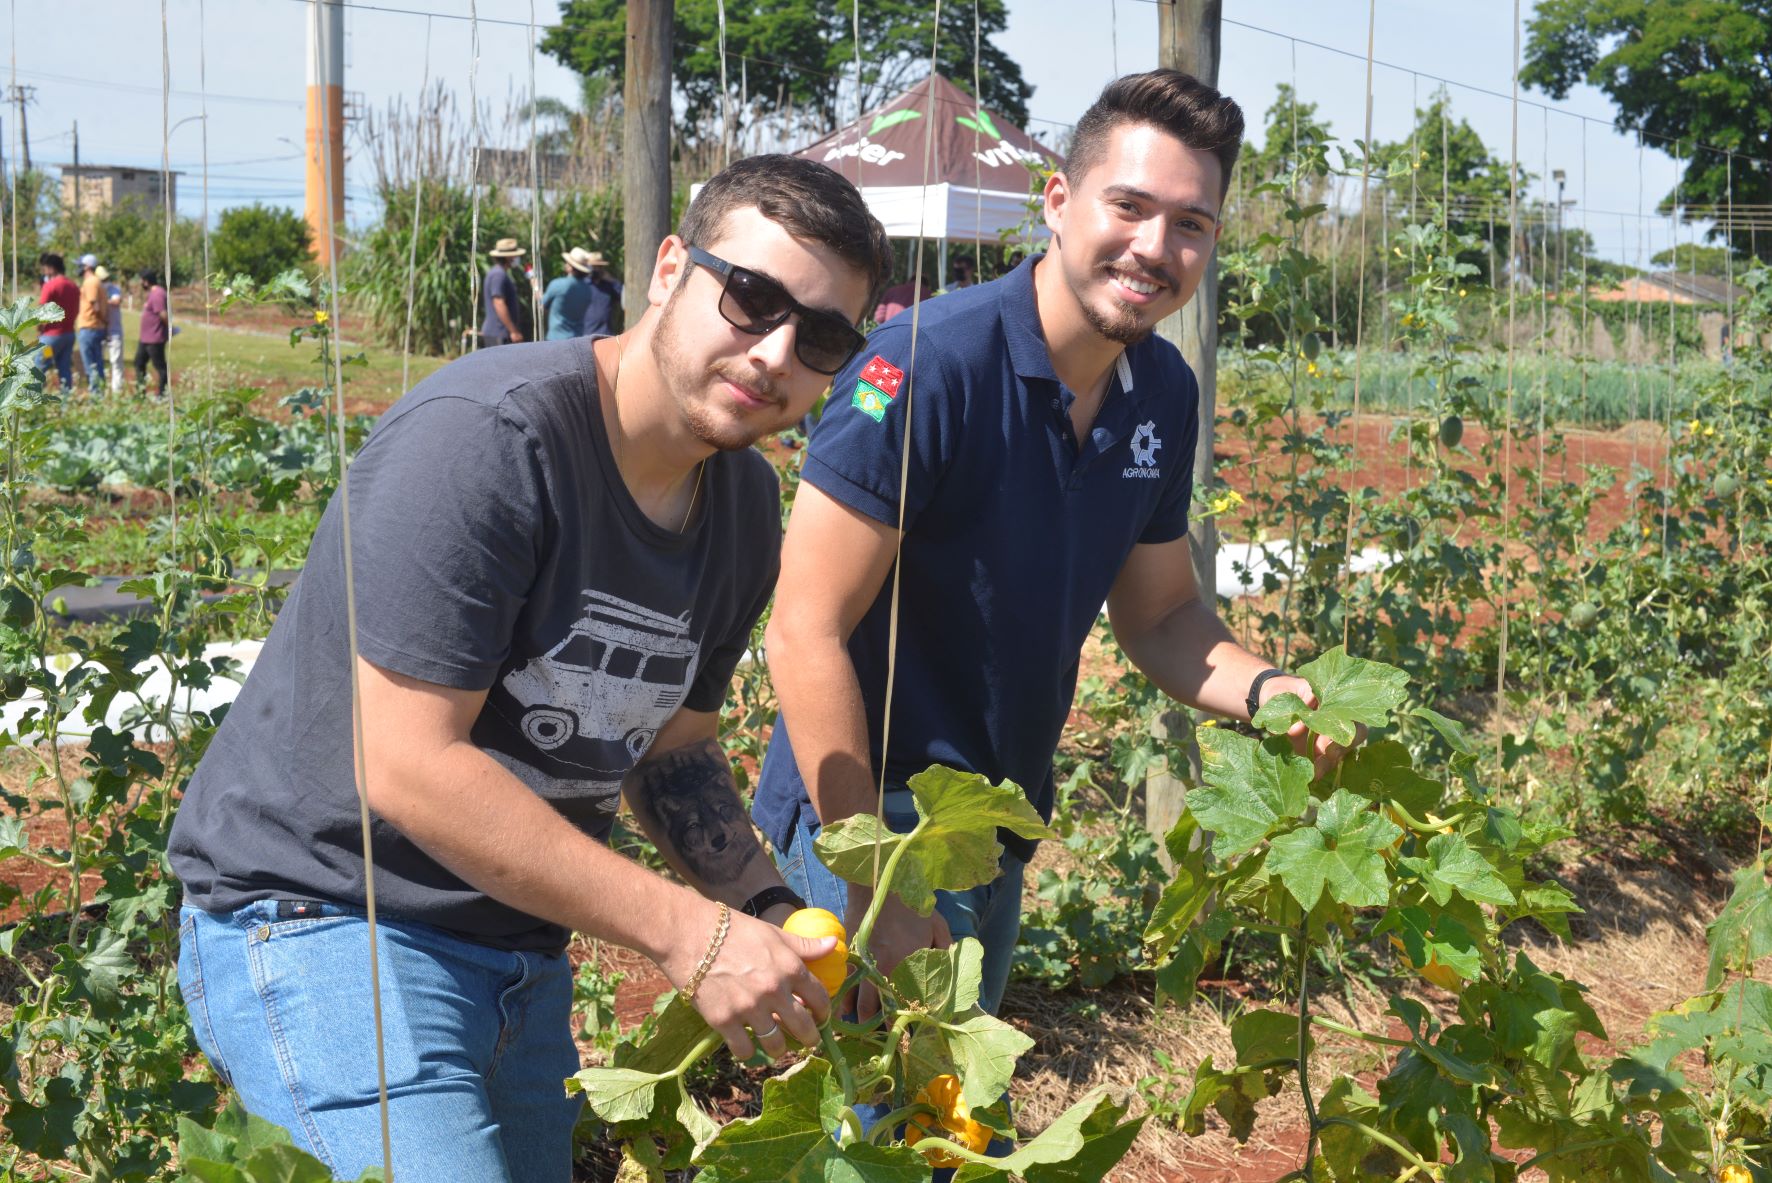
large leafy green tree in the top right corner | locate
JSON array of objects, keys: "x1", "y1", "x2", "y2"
[{"x1": 1520, "y1": 0, "x2": 1772, "y2": 260}]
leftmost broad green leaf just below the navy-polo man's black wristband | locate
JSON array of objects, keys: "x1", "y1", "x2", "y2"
[{"x1": 1187, "y1": 728, "x2": 1311, "y2": 859}]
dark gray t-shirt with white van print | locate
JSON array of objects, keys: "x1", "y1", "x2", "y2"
[{"x1": 168, "y1": 338, "x2": 781, "y2": 949}]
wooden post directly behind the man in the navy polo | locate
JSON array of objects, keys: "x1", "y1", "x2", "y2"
[{"x1": 1145, "y1": 0, "x2": 1224, "y2": 853}]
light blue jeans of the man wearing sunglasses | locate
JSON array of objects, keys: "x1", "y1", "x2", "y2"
[{"x1": 179, "y1": 900, "x2": 581, "y2": 1183}]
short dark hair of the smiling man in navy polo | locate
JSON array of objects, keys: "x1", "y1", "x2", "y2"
[{"x1": 1063, "y1": 69, "x2": 1242, "y2": 200}]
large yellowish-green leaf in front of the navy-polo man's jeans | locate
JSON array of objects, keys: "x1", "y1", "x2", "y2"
[{"x1": 817, "y1": 765, "x2": 1054, "y2": 916}]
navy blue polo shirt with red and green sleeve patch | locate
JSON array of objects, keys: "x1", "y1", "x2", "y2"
[{"x1": 753, "y1": 255, "x2": 1200, "y2": 857}]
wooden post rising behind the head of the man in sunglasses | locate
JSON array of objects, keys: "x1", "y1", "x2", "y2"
[{"x1": 622, "y1": 0, "x2": 677, "y2": 324}]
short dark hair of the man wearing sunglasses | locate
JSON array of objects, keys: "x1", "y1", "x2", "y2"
[{"x1": 677, "y1": 154, "x2": 891, "y2": 317}]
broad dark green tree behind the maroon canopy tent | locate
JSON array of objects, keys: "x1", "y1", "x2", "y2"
[{"x1": 540, "y1": 0, "x2": 1033, "y2": 140}]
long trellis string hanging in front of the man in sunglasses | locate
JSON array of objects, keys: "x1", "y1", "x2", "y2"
[{"x1": 312, "y1": 4, "x2": 393, "y2": 1183}]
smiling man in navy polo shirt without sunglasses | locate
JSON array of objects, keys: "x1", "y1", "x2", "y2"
[{"x1": 755, "y1": 69, "x2": 1341, "y2": 1015}]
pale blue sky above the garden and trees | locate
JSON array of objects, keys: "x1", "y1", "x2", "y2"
[{"x1": 0, "y1": 0, "x2": 1690, "y2": 260}]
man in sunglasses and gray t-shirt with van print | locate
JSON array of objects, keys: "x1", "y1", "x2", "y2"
[{"x1": 168, "y1": 156, "x2": 890, "y2": 1183}]
